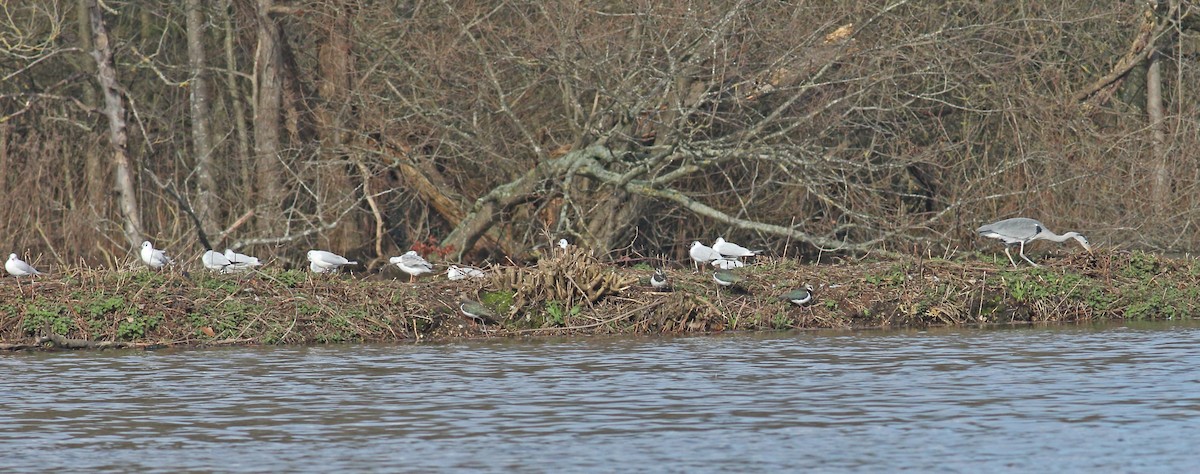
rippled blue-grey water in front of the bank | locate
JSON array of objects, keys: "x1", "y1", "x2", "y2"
[{"x1": 0, "y1": 323, "x2": 1200, "y2": 473}]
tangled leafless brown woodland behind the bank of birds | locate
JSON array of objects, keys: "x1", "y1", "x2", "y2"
[{"x1": 0, "y1": 0, "x2": 1200, "y2": 266}]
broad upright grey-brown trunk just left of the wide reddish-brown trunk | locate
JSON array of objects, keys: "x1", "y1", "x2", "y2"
[{"x1": 254, "y1": 0, "x2": 284, "y2": 234}]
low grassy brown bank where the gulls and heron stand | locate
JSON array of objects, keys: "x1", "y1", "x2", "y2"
[{"x1": 0, "y1": 250, "x2": 1200, "y2": 350}]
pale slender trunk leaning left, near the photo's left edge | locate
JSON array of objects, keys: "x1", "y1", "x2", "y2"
[{"x1": 86, "y1": 0, "x2": 144, "y2": 247}]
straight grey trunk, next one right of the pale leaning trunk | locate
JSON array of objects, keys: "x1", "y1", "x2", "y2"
[{"x1": 187, "y1": 0, "x2": 218, "y2": 234}]
